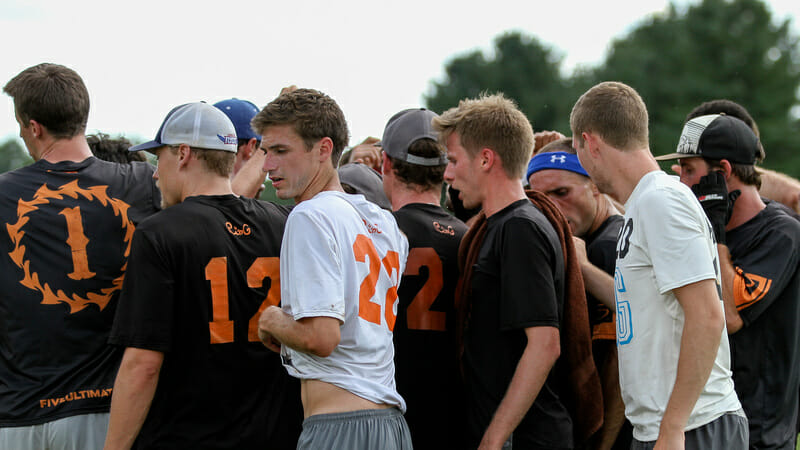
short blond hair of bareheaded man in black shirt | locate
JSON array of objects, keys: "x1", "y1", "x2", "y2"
[{"x1": 433, "y1": 94, "x2": 534, "y2": 178}]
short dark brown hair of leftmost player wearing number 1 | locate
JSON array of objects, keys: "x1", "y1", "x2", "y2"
[{"x1": 3, "y1": 63, "x2": 89, "y2": 139}]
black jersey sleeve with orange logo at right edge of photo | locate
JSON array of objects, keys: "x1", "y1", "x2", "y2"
[{"x1": 733, "y1": 224, "x2": 800, "y2": 326}]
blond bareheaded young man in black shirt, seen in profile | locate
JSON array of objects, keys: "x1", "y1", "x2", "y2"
[{"x1": 433, "y1": 95, "x2": 574, "y2": 449}]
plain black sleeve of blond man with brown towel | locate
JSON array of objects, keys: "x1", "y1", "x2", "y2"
[{"x1": 500, "y1": 219, "x2": 559, "y2": 330}]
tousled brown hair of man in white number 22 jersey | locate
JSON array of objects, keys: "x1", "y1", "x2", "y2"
[{"x1": 250, "y1": 89, "x2": 349, "y2": 167}]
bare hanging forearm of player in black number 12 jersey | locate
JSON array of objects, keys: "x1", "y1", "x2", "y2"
[{"x1": 105, "y1": 348, "x2": 164, "y2": 450}]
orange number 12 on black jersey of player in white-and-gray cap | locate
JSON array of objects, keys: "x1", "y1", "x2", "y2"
[{"x1": 206, "y1": 257, "x2": 281, "y2": 344}]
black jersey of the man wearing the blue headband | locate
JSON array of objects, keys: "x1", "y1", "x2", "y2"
[{"x1": 586, "y1": 214, "x2": 624, "y2": 341}]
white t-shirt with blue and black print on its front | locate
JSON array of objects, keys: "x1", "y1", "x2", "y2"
[{"x1": 614, "y1": 170, "x2": 741, "y2": 441}]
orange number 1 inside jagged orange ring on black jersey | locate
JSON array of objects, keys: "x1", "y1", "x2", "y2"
[{"x1": 6, "y1": 180, "x2": 135, "y2": 314}]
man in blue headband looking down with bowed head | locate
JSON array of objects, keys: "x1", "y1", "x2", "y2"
[{"x1": 527, "y1": 138, "x2": 631, "y2": 449}]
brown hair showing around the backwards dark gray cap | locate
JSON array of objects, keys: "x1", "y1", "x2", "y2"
[{"x1": 384, "y1": 139, "x2": 447, "y2": 192}]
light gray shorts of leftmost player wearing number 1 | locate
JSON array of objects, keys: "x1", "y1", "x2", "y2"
[{"x1": 0, "y1": 413, "x2": 108, "y2": 450}]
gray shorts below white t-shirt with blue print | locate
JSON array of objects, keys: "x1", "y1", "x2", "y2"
[{"x1": 631, "y1": 409, "x2": 750, "y2": 450}]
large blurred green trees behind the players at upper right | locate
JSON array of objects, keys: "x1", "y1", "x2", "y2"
[{"x1": 425, "y1": 0, "x2": 800, "y2": 177}]
